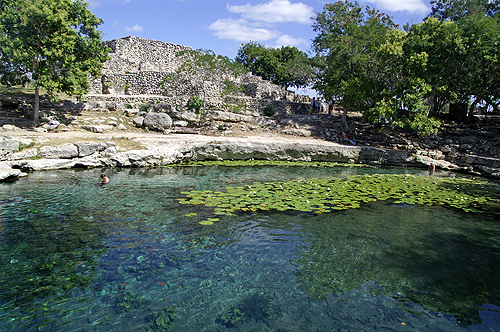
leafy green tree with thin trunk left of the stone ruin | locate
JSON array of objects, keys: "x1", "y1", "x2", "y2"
[{"x1": 0, "y1": 0, "x2": 109, "y2": 123}]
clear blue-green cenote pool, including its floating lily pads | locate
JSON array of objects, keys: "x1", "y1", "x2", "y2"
[{"x1": 0, "y1": 164, "x2": 500, "y2": 332}]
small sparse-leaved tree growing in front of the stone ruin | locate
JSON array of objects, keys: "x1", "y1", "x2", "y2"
[{"x1": 160, "y1": 49, "x2": 246, "y2": 108}]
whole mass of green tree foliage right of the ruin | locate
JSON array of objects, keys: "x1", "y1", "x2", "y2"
[{"x1": 313, "y1": 0, "x2": 500, "y2": 130}]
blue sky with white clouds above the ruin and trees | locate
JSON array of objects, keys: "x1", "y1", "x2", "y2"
[{"x1": 88, "y1": 0, "x2": 430, "y2": 58}]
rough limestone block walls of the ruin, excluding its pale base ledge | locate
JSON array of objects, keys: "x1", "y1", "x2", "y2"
[{"x1": 90, "y1": 36, "x2": 309, "y2": 111}]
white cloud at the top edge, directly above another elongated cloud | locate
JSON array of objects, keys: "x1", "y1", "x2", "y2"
[{"x1": 227, "y1": 0, "x2": 314, "y2": 24}]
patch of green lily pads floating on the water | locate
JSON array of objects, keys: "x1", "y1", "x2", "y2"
[{"x1": 178, "y1": 174, "x2": 500, "y2": 215}]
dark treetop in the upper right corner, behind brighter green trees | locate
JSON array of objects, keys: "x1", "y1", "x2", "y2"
[{"x1": 429, "y1": 0, "x2": 500, "y2": 21}]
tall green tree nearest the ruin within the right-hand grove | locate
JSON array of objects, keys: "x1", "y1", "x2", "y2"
[{"x1": 313, "y1": 1, "x2": 397, "y2": 124}]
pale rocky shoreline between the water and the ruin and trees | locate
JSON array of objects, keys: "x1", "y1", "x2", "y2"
[{"x1": 0, "y1": 96, "x2": 500, "y2": 181}]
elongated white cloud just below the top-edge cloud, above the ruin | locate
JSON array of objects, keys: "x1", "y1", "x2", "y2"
[{"x1": 208, "y1": 18, "x2": 281, "y2": 42}]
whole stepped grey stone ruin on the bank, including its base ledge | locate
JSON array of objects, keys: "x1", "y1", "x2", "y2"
[{"x1": 86, "y1": 36, "x2": 310, "y2": 114}]
